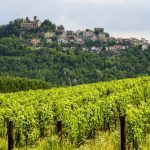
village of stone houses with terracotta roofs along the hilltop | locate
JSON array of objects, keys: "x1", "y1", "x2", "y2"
[{"x1": 1, "y1": 16, "x2": 149, "y2": 53}]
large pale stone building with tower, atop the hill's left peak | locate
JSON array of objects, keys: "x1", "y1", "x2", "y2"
[{"x1": 21, "y1": 16, "x2": 41, "y2": 30}]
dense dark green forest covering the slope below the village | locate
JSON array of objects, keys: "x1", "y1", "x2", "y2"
[{"x1": 0, "y1": 37, "x2": 150, "y2": 86}]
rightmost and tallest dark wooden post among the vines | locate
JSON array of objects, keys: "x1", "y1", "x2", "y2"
[{"x1": 120, "y1": 115, "x2": 126, "y2": 150}]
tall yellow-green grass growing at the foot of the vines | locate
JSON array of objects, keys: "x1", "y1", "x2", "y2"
[{"x1": 0, "y1": 132, "x2": 150, "y2": 150}]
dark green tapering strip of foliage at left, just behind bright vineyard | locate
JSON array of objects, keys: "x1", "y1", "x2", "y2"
[{"x1": 0, "y1": 76, "x2": 52, "y2": 93}]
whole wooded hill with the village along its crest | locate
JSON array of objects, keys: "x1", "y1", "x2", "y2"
[{"x1": 0, "y1": 16, "x2": 150, "y2": 86}]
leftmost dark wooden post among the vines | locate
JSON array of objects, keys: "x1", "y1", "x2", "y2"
[{"x1": 7, "y1": 120, "x2": 14, "y2": 150}]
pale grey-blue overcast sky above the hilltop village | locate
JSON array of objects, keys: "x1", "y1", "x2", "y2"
[{"x1": 0, "y1": 0, "x2": 150, "y2": 40}]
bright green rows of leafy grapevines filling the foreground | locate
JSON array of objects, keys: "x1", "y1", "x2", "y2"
[{"x1": 0, "y1": 77, "x2": 150, "y2": 150}]
